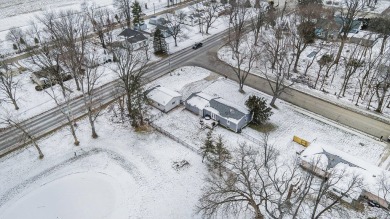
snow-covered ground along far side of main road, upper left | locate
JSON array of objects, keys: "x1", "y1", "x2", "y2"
[{"x1": 0, "y1": 6, "x2": 232, "y2": 123}]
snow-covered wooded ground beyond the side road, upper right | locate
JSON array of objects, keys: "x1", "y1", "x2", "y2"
[{"x1": 218, "y1": 30, "x2": 390, "y2": 119}]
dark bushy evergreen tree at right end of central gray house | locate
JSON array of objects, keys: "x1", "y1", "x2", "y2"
[{"x1": 245, "y1": 95, "x2": 273, "y2": 125}]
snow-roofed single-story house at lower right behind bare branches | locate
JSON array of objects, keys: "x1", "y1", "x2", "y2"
[{"x1": 300, "y1": 143, "x2": 390, "y2": 209}]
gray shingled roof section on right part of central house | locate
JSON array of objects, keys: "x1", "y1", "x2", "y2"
[{"x1": 210, "y1": 98, "x2": 250, "y2": 120}]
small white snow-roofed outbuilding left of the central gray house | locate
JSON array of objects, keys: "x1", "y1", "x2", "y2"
[{"x1": 146, "y1": 85, "x2": 182, "y2": 113}]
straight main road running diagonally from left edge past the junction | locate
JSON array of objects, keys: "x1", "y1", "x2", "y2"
[{"x1": 0, "y1": 29, "x2": 226, "y2": 155}]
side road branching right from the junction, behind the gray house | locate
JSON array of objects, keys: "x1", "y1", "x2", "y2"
[{"x1": 188, "y1": 42, "x2": 390, "y2": 141}]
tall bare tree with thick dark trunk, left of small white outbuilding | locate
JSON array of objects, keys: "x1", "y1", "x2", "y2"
[{"x1": 113, "y1": 44, "x2": 148, "y2": 128}]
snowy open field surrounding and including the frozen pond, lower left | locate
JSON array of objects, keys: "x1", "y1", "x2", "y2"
[{"x1": 0, "y1": 114, "x2": 206, "y2": 219}]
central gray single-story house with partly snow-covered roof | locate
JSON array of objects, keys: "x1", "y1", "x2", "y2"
[{"x1": 185, "y1": 92, "x2": 252, "y2": 132}]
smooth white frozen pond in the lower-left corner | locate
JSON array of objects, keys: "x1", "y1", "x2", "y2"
[{"x1": 2, "y1": 172, "x2": 121, "y2": 219}]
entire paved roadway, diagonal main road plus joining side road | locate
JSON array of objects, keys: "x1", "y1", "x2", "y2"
[{"x1": 0, "y1": 4, "x2": 390, "y2": 155}]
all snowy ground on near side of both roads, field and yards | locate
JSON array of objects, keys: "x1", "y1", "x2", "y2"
[{"x1": 0, "y1": 67, "x2": 389, "y2": 219}]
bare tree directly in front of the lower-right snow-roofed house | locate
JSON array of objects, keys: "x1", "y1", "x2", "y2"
[{"x1": 291, "y1": 158, "x2": 363, "y2": 219}]
